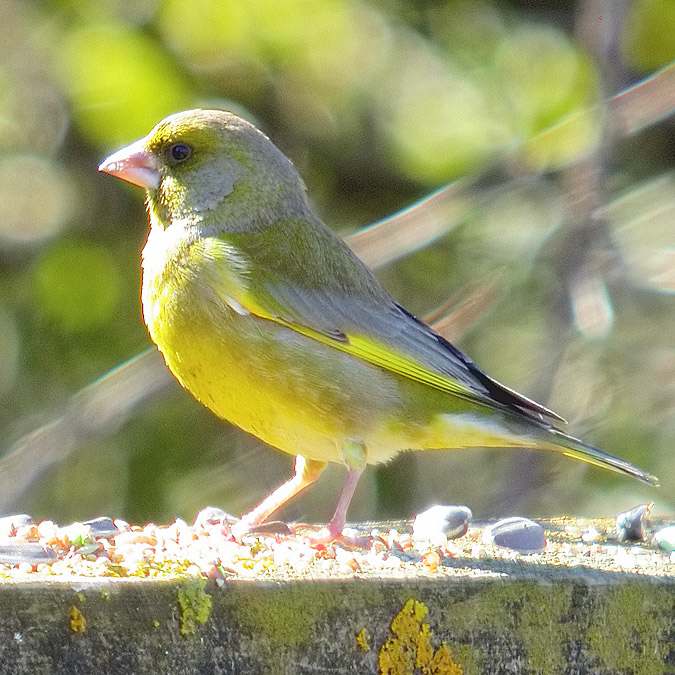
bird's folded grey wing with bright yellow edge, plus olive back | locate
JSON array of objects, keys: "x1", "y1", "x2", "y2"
[{"x1": 213, "y1": 224, "x2": 563, "y2": 422}]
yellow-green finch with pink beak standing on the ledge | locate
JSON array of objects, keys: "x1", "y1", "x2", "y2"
[{"x1": 99, "y1": 109, "x2": 658, "y2": 542}]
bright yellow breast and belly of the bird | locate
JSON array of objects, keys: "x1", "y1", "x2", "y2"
[{"x1": 137, "y1": 224, "x2": 456, "y2": 462}]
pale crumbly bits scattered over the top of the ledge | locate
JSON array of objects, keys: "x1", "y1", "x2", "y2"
[{"x1": 0, "y1": 508, "x2": 675, "y2": 583}]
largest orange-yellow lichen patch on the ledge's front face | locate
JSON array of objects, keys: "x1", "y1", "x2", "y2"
[{"x1": 378, "y1": 598, "x2": 464, "y2": 675}]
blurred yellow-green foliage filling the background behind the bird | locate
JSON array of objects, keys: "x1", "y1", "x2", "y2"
[{"x1": 0, "y1": 0, "x2": 675, "y2": 519}]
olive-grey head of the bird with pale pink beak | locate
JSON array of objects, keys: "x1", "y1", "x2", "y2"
[{"x1": 99, "y1": 110, "x2": 306, "y2": 229}]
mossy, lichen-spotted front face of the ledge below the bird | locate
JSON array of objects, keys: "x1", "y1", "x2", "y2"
[{"x1": 0, "y1": 563, "x2": 675, "y2": 675}]
